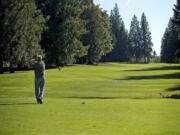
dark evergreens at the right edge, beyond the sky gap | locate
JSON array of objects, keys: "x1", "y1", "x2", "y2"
[{"x1": 161, "y1": 0, "x2": 180, "y2": 63}]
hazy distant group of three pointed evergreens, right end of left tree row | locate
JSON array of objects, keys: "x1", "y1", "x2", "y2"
[{"x1": 103, "y1": 4, "x2": 153, "y2": 63}]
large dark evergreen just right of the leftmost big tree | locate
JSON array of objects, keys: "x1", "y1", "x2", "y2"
[{"x1": 45, "y1": 0, "x2": 87, "y2": 65}]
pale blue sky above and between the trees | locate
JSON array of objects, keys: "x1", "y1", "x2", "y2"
[{"x1": 94, "y1": 0, "x2": 176, "y2": 55}]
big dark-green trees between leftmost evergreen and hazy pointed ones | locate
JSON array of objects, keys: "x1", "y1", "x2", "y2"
[{"x1": 36, "y1": 0, "x2": 112, "y2": 65}]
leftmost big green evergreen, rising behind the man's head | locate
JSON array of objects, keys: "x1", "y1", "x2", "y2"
[{"x1": 0, "y1": 0, "x2": 45, "y2": 67}]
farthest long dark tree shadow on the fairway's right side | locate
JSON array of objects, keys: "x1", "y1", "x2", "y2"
[{"x1": 126, "y1": 65, "x2": 180, "y2": 71}]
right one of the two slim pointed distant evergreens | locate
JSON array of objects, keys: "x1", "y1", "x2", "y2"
[{"x1": 140, "y1": 13, "x2": 153, "y2": 62}]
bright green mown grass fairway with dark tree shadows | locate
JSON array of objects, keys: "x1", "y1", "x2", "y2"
[{"x1": 0, "y1": 63, "x2": 180, "y2": 135}]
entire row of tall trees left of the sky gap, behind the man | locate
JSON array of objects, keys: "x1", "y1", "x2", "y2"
[{"x1": 0, "y1": 0, "x2": 153, "y2": 73}]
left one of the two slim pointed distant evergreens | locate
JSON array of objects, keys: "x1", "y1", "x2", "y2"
[{"x1": 128, "y1": 15, "x2": 142, "y2": 62}]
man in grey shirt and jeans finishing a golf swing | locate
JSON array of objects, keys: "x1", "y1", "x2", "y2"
[{"x1": 33, "y1": 55, "x2": 45, "y2": 104}]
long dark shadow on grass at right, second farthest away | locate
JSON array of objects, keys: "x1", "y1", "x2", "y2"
[{"x1": 115, "y1": 73, "x2": 180, "y2": 80}]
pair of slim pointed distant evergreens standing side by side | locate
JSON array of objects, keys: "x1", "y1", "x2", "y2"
[{"x1": 128, "y1": 13, "x2": 153, "y2": 63}]
